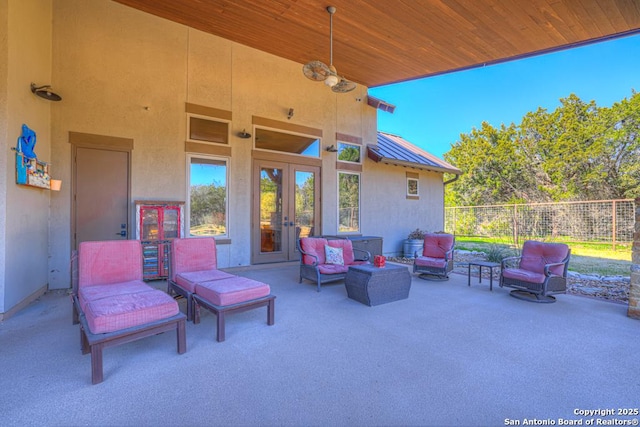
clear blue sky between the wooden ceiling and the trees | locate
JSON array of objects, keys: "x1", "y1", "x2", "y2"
[{"x1": 369, "y1": 31, "x2": 640, "y2": 158}]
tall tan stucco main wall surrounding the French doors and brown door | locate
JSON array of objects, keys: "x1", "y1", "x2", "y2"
[{"x1": 50, "y1": 0, "x2": 376, "y2": 288}]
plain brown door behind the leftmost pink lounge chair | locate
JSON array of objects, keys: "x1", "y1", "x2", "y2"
[{"x1": 72, "y1": 146, "x2": 130, "y2": 249}]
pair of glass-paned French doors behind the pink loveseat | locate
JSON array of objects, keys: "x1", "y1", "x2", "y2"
[{"x1": 251, "y1": 160, "x2": 320, "y2": 264}]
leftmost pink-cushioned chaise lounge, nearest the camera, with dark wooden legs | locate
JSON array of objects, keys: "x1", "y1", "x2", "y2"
[{"x1": 72, "y1": 240, "x2": 187, "y2": 384}]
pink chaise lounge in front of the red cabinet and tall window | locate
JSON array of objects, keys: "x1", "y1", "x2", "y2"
[{"x1": 168, "y1": 237, "x2": 276, "y2": 341}]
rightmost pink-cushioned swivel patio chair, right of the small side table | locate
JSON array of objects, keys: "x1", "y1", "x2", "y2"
[{"x1": 500, "y1": 240, "x2": 571, "y2": 303}]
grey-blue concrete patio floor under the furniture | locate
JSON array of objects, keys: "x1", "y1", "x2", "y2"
[{"x1": 0, "y1": 264, "x2": 640, "y2": 426}]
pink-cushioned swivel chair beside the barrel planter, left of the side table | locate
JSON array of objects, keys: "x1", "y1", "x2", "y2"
[{"x1": 413, "y1": 233, "x2": 456, "y2": 280}]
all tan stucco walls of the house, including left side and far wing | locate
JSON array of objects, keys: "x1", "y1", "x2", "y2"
[{"x1": 0, "y1": 0, "x2": 443, "y2": 311}]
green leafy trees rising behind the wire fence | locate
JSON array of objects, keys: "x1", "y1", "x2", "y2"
[{"x1": 444, "y1": 91, "x2": 640, "y2": 205}]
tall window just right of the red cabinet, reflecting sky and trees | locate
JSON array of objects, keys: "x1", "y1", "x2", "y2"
[{"x1": 188, "y1": 156, "x2": 229, "y2": 236}]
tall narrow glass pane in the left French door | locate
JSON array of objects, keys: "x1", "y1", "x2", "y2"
[{"x1": 260, "y1": 168, "x2": 283, "y2": 252}]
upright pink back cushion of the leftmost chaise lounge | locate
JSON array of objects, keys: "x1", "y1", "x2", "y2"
[{"x1": 78, "y1": 240, "x2": 142, "y2": 288}]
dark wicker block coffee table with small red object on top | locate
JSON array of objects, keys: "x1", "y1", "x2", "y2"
[{"x1": 344, "y1": 264, "x2": 411, "y2": 306}]
